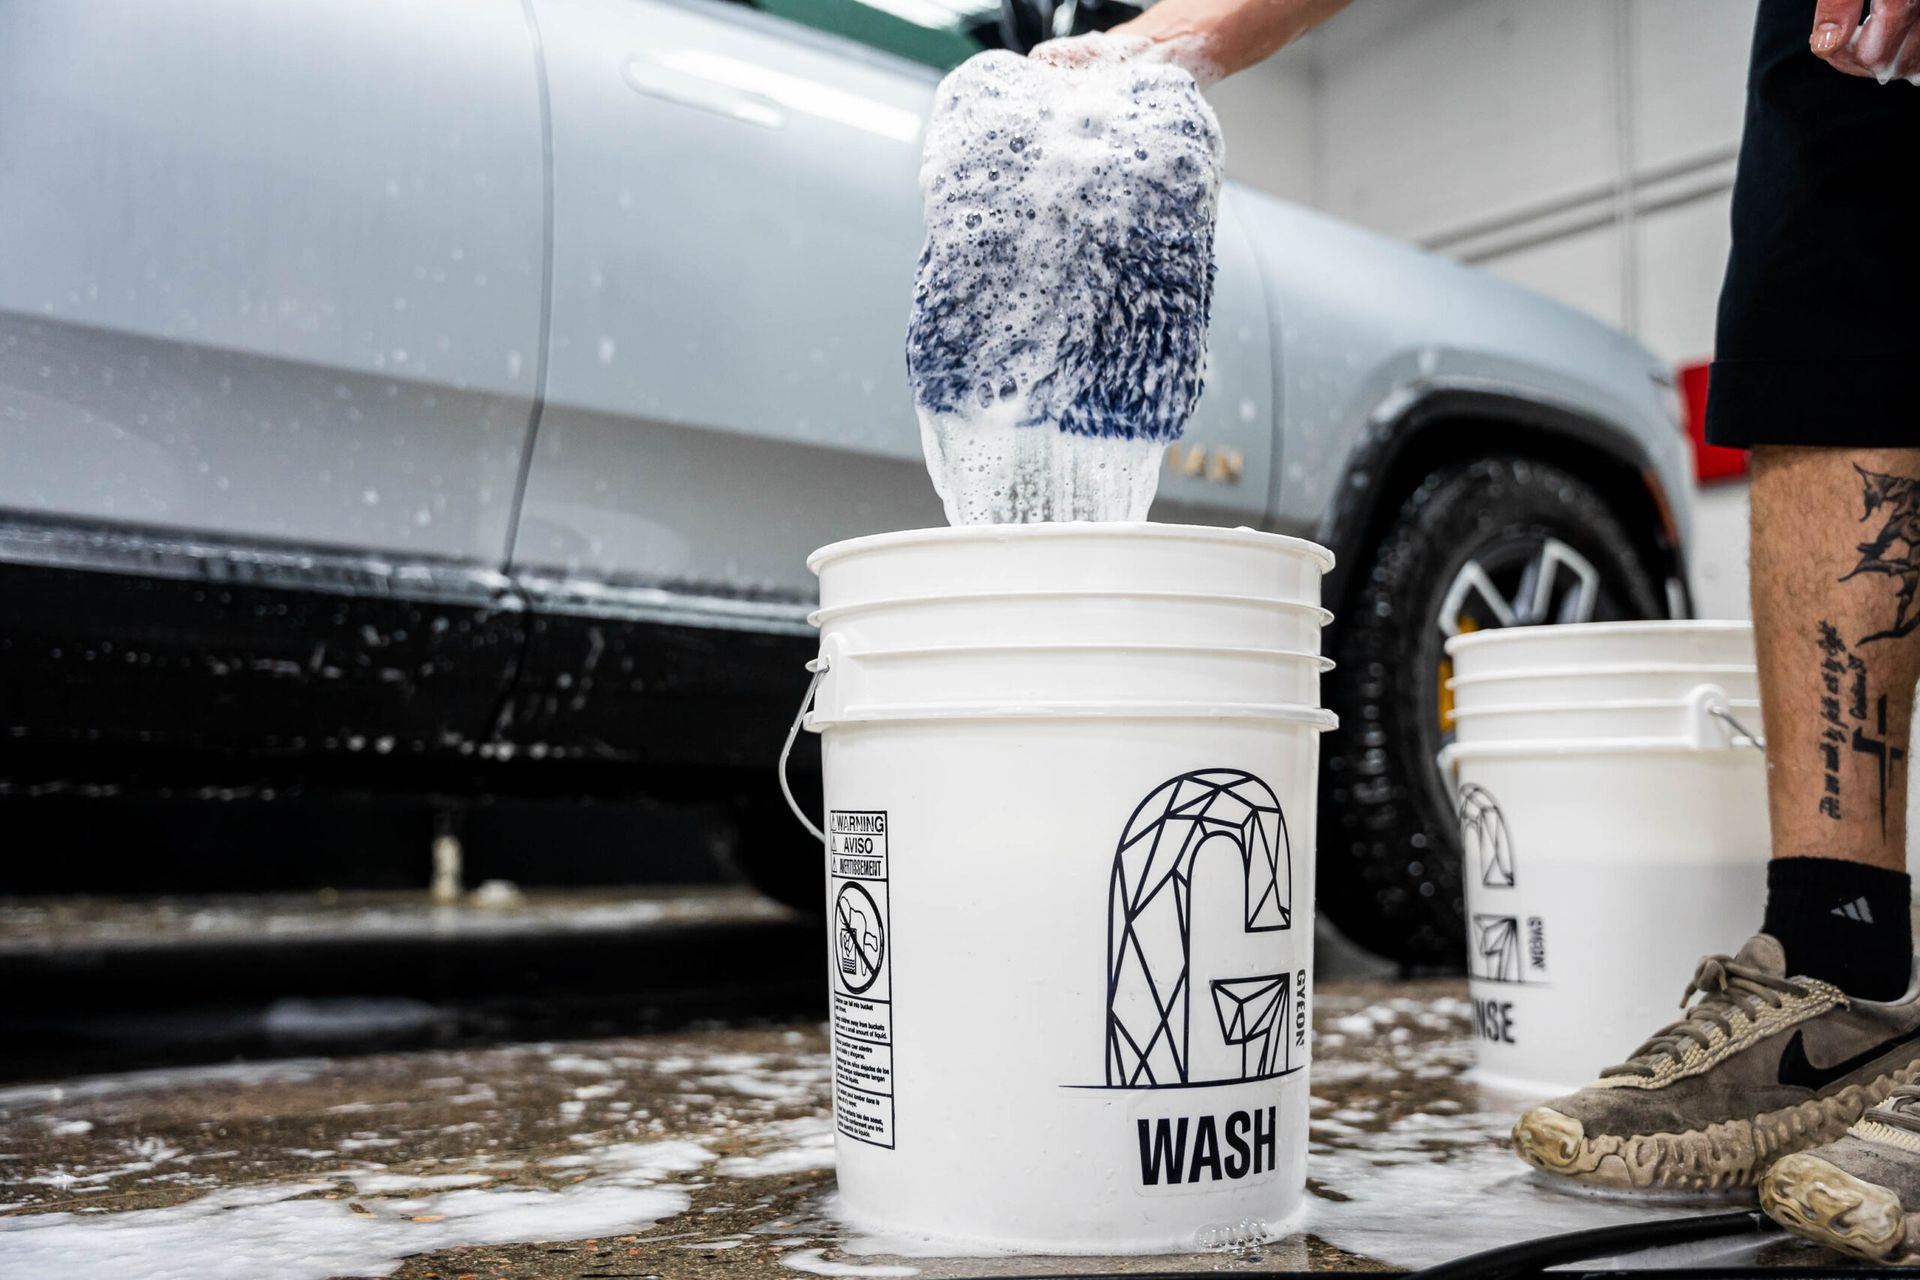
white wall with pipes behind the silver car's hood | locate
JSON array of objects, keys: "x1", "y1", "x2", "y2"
[{"x1": 1213, "y1": 0, "x2": 1753, "y2": 616}]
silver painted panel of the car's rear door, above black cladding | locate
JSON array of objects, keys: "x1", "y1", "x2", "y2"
[{"x1": 0, "y1": 0, "x2": 545, "y2": 568}]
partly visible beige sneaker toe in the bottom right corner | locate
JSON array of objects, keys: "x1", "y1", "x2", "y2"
[{"x1": 1761, "y1": 1084, "x2": 1920, "y2": 1267}]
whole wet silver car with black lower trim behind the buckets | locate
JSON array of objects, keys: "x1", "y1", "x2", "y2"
[{"x1": 0, "y1": 0, "x2": 1690, "y2": 963}]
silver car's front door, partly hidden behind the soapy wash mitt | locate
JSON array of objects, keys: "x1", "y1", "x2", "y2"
[{"x1": 515, "y1": 0, "x2": 1273, "y2": 616}]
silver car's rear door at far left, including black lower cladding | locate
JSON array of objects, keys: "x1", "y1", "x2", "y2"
[{"x1": 0, "y1": 0, "x2": 547, "y2": 759}]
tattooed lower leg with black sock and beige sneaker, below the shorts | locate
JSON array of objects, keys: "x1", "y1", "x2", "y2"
[{"x1": 1513, "y1": 445, "x2": 1920, "y2": 1189}]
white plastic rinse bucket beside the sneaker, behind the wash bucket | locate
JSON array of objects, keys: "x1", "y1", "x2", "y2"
[{"x1": 1444, "y1": 622, "x2": 1768, "y2": 1094}]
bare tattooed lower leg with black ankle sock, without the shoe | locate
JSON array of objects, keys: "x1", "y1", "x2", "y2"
[{"x1": 1751, "y1": 445, "x2": 1920, "y2": 1000}]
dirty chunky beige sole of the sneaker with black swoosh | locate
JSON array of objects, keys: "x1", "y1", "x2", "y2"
[{"x1": 1513, "y1": 1067, "x2": 1920, "y2": 1192}]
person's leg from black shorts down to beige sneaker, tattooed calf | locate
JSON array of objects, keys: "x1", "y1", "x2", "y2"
[{"x1": 1513, "y1": 0, "x2": 1920, "y2": 1205}]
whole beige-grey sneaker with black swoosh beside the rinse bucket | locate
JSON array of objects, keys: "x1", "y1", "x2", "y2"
[{"x1": 1513, "y1": 933, "x2": 1920, "y2": 1192}]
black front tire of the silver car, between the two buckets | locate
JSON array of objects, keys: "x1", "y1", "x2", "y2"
[{"x1": 1317, "y1": 457, "x2": 1667, "y2": 969}]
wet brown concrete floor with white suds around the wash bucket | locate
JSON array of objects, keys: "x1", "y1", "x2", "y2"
[{"x1": 0, "y1": 898, "x2": 1858, "y2": 1280}]
